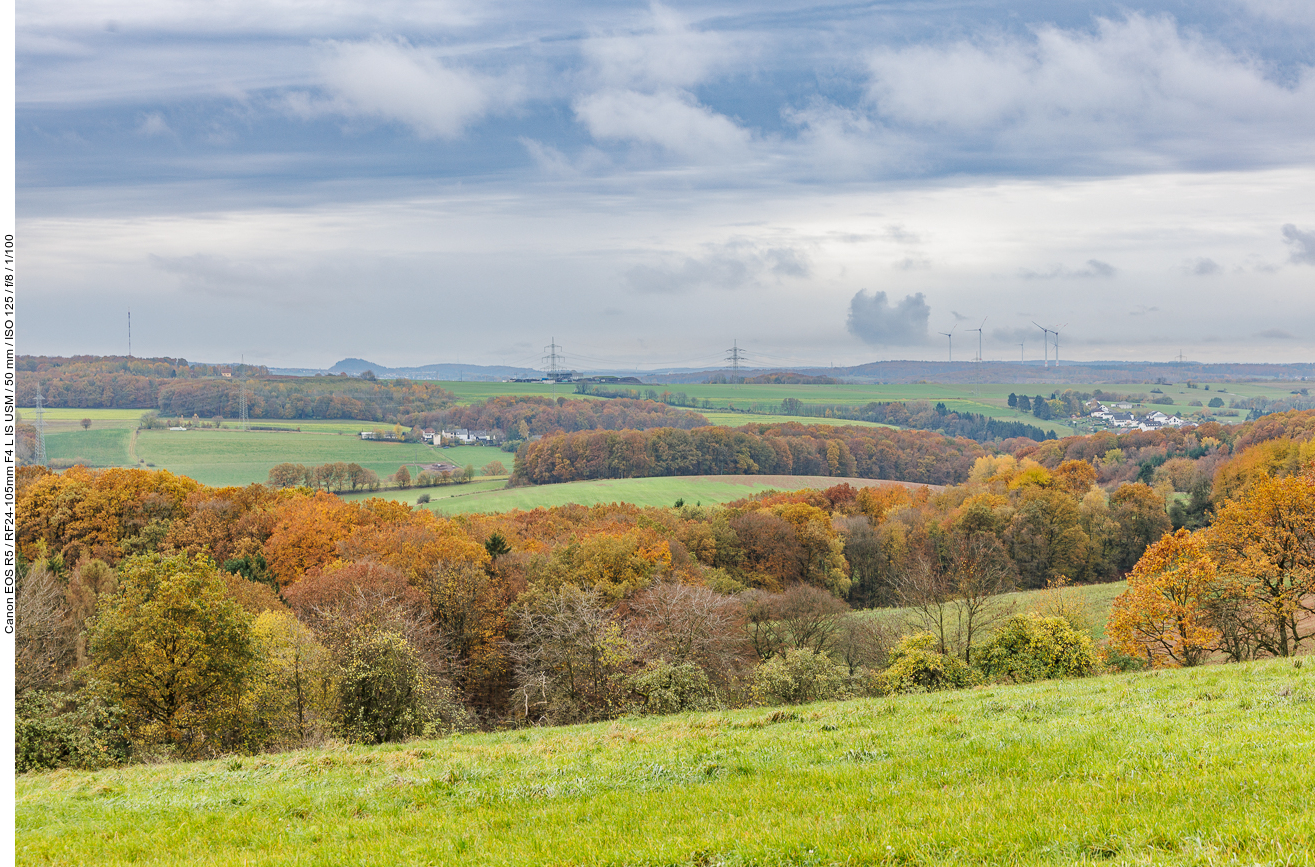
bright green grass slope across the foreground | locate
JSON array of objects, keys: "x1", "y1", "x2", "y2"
[{"x1": 17, "y1": 660, "x2": 1315, "y2": 866}]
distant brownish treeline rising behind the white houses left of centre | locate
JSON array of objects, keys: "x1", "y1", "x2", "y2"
[{"x1": 404, "y1": 395, "x2": 707, "y2": 439}]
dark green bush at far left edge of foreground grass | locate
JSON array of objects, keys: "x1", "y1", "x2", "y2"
[{"x1": 14, "y1": 689, "x2": 129, "y2": 774}]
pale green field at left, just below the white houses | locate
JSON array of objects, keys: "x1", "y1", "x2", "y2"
[{"x1": 126, "y1": 429, "x2": 512, "y2": 485}]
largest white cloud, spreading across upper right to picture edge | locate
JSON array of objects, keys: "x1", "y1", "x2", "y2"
[{"x1": 867, "y1": 13, "x2": 1315, "y2": 170}]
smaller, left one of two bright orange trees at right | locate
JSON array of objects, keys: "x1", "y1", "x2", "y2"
[{"x1": 1109, "y1": 530, "x2": 1219, "y2": 668}]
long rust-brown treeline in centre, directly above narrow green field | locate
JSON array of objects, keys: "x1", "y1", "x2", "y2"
[{"x1": 512, "y1": 422, "x2": 985, "y2": 484}]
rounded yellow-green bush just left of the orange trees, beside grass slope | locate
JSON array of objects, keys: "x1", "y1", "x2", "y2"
[{"x1": 977, "y1": 613, "x2": 1099, "y2": 683}]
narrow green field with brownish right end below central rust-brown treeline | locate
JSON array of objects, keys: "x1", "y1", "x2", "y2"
[{"x1": 430, "y1": 475, "x2": 938, "y2": 514}]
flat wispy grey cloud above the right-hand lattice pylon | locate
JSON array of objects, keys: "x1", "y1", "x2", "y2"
[{"x1": 626, "y1": 242, "x2": 813, "y2": 293}]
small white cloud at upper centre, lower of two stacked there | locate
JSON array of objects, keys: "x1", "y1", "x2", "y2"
[{"x1": 575, "y1": 91, "x2": 750, "y2": 159}]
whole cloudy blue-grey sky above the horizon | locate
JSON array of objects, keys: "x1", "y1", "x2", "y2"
[{"x1": 16, "y1": 0, "x2": 1315, "y2": 370}]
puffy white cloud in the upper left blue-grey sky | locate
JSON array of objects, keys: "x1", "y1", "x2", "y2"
[{"x1": 287, "y1": 38, "x2": 502, "y2": 138}]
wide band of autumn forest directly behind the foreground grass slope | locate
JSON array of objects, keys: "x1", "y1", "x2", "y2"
[{"x1": 16, "y1": 412, "x2": 1315, "y2": 770}]
